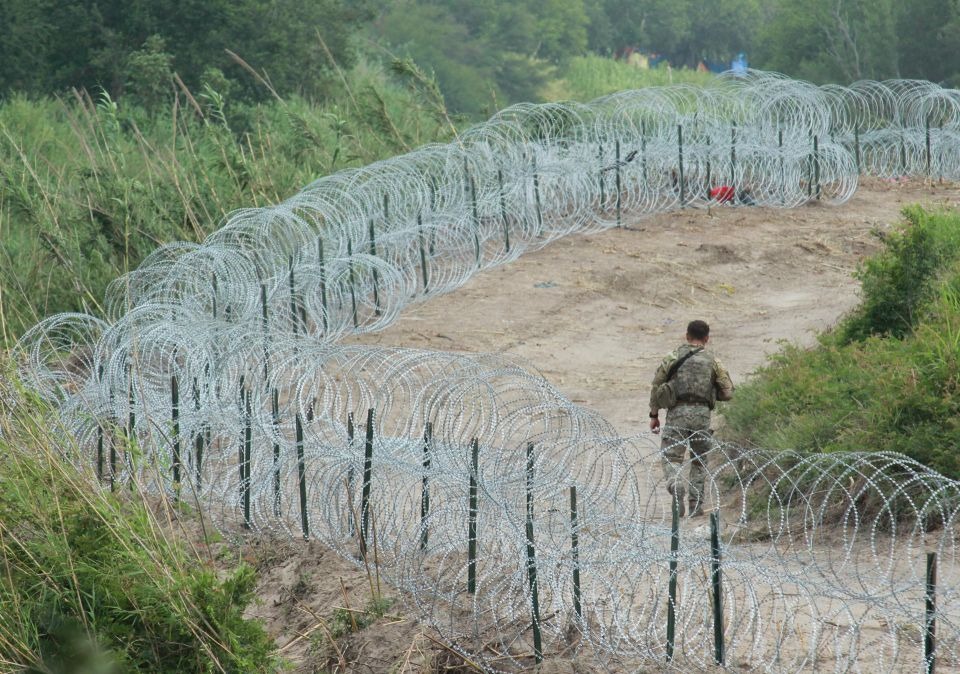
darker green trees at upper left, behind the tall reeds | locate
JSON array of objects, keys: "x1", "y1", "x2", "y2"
[{"x1": 0, "y1": 0, "x2": 371, "y2": 103}]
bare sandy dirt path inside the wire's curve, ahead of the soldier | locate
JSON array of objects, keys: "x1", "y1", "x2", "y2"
[{"x1": 353, "y1": 181, "x2": 960, "y2": 435}]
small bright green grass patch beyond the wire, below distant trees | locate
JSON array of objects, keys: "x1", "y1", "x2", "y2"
[{"x1": 543, "y1": 55, "x2": 715, "y2": 101}]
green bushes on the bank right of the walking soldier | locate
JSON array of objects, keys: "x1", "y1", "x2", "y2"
[{"x1": 724, "y1": 208, "x2": 960, "y2": 478}]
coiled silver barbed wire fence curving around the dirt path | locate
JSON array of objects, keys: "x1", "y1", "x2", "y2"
[{"x1": 17, "y1": 73, "x2": 960, "y2": 671}]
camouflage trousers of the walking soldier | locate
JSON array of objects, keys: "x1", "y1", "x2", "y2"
[{"x1": 660, "y1": 405, "x2": 714, "y2": 504}]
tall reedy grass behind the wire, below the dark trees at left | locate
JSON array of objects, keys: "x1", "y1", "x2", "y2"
[{"x1": 0, "y1": 57, "x2": 451, "y2": 344}]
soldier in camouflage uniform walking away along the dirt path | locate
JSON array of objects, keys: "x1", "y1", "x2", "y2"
[{"x1": 650, "y1": 321, "x2": 733, "y2": 517}]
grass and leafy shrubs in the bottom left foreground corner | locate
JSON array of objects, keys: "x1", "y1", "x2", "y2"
[{"x1": 0, "y1": 368, "x2": 279, "y2": 674}]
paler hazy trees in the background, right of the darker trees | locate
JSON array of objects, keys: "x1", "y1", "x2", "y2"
[{"x1": 366, "y1": 0, "x2": 960, "y2": 94}]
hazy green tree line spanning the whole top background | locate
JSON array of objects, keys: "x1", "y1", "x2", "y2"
[{"x1": 0, "y1": 0, "x2": 960, "y2": 113}]
